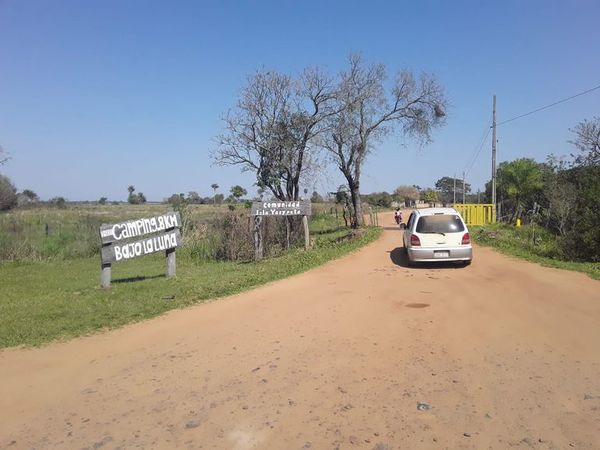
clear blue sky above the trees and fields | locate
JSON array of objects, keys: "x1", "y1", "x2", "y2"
[{"x1": 0, "y1": 0, "x2": 600, "y2": 200}]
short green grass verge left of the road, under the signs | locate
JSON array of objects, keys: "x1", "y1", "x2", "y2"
[{"x1": 0, "y1": 224, "x2": 380, "y2": 348}]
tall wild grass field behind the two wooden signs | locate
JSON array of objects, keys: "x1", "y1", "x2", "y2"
[{"x1": 0, "y1": 204, "x2": 339, "y2": 262}]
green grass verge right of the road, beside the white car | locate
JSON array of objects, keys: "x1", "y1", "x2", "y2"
[{"x1": 470, "y1": 224, "x2": 600, "y2": 280}]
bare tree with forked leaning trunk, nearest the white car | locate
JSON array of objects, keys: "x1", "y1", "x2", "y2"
[{"x1": 324, "y1": 56, "x2": 446, "y2": 227}]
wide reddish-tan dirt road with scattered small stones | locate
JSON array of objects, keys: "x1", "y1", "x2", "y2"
[{"x1": 0, "y1": 217, "x2": 600, "y2": 450}]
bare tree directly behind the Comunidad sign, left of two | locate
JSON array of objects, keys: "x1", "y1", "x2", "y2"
[{"x1": 212, "y1": 69, "x2": 335, "y2": 200}]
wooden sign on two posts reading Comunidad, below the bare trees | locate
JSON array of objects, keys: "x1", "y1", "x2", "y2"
[{"x1": 250, "y1": 201, "x2": 312, "y2": 261}]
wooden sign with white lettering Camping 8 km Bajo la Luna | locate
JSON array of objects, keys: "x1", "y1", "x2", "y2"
[{"x1": 100, "y1": 212, "x2": 181, "y2": 288}]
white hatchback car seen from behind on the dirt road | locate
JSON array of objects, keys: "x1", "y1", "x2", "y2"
[{"x1": 401, "y1": 208, "x2": 473, "y2": 265}]
